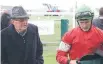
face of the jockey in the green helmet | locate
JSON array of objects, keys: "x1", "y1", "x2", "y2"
[{"x1": 78, "y1": 19, "x2": 91, "y2": 31}]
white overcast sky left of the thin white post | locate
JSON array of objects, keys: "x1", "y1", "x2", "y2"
[{"x1": 0, "y1": 0, "x2": 74, "y2": 9}]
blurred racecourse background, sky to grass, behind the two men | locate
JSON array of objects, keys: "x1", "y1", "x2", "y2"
[{"x1": 0, "y1": 0, "x2": 103, "y2": 64}]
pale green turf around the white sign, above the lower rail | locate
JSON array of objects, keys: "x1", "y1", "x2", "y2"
[{"x1": 30, "y1": 15, "x2": 72, "y2": 42}]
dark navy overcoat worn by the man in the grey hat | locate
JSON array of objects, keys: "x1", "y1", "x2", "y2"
[{"x1": 1, "y1": 24, "x2": 44, "y2": 64}]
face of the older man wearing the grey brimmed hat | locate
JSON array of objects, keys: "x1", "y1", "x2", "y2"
[{"x1": 12, "y1": 19, "x2": 28, "y2": 32}]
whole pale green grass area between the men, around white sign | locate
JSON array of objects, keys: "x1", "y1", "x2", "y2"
[{"x1": 31, "y1": 16, "x2": 72, "y2": 64}]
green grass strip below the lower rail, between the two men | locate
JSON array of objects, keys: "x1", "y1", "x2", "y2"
[{"x1": 43, "y1": 46, "x2": 58, "y2": 64}]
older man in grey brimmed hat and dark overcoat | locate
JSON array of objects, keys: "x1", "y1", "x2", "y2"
[{"x1": 1, "y1": 6, "x2": 44, "y2": 64}]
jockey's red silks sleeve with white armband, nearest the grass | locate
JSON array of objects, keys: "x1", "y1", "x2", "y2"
[{"x1": 56, "y1": 31, "x2": 73, "y2": 64}]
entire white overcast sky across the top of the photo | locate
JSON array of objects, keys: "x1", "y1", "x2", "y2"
[{"x1": 0, "y1": 0, "x2": 103, "y2": 10}]
